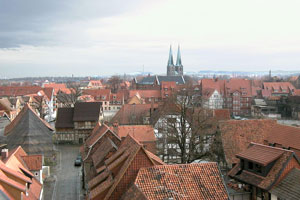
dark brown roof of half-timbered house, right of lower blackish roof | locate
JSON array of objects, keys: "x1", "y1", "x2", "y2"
[{"x1": 73, "y1": 102, "x2": 102, "y2": 122}]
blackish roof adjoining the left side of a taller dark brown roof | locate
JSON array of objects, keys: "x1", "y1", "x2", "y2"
[{"x1": 55, "y1": 108, "x2": 74, "y2": 128}]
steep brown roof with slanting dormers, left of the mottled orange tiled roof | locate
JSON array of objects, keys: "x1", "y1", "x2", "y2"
[{"x1": 88, "y1": 135, "x2": 164, "y2": 200}]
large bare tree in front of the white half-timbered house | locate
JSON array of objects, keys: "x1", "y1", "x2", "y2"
[{"x1": 154, "y1": 85, "x2": 216, "y2": 163}]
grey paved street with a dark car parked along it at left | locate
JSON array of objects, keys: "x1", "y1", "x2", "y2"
[{"x1": 52, "y1": 145, "x2": 81, "y2": 200}]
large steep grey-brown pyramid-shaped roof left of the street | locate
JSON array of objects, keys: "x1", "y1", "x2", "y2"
[{"x1": 4, "y1": 105, "x2": 53, "y2": 154}]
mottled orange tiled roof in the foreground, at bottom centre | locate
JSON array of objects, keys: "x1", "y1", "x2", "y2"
[{"x1": 126, "y1": 163, "x2": 229, "y2": 200}]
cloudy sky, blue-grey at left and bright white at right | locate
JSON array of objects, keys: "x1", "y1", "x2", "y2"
[{"x1": 0, "y1": 0, "x2": 300, "y2": 78}]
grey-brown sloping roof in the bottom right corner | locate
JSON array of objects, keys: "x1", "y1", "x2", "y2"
[{"x1": 270, "y1": 168, "x2": 300, "y2": 200}]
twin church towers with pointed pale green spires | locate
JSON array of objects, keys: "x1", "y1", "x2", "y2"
[{"x1": 167, "y1": 45, "x2": 183, "y2": 76}]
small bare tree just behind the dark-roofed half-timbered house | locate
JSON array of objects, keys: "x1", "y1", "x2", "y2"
[{"x1": 56, "y1": 83, "x2": 82, "y2": 107}]
